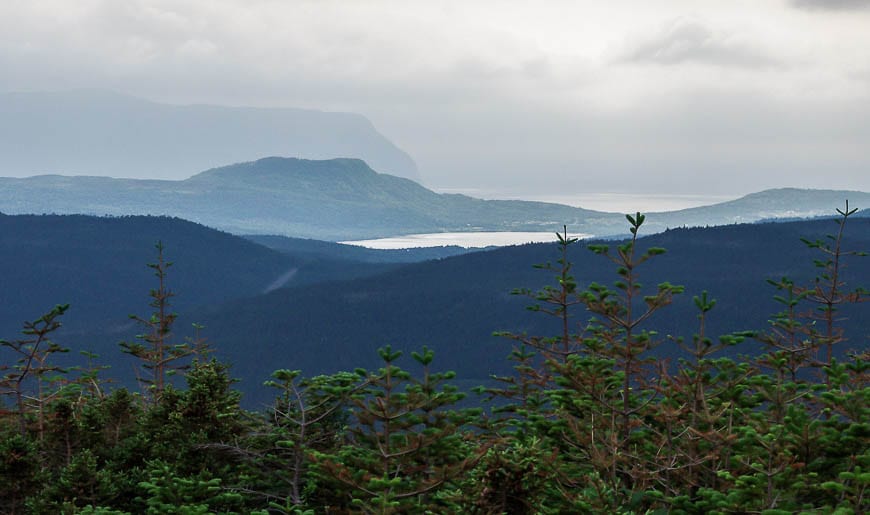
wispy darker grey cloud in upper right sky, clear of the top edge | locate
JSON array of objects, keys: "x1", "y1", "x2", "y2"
[{"x1": 622, "y1": 17, "x2": 778, "y2": 68}]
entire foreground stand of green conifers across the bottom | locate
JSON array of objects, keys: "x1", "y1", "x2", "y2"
[{"x1": 0, "y1": 205, "x2": 870, "y2": 514}]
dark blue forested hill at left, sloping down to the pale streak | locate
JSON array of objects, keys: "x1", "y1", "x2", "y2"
[{"x1": 0, "y1": 215, "x2": 299, "y2": 339}]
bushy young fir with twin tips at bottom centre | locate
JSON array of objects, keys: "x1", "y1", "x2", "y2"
[{"x1": 315, "y1": 346, "x2": 485, "y2": 513}]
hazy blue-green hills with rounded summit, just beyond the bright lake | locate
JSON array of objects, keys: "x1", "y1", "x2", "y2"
[{"x1": 0, "y1": 157, "x2": 870, "y2": 241}]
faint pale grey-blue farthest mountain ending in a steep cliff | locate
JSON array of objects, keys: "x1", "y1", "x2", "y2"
[{"x1": 0, "y1": 90, "x2": 420, "y2": 180}]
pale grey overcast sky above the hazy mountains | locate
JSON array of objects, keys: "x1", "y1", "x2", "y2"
[{"x1": 0, "y1": 0, "x2": 870, "y2": 196}]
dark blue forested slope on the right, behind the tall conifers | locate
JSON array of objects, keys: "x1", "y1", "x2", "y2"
[{"x1": 194, "y1": 218, "x2": 870, "y2": 404}]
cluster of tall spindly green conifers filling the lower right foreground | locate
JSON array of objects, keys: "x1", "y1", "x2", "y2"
[{"x1": 488, "y1": 207, "x2": 870, "y2": 513}]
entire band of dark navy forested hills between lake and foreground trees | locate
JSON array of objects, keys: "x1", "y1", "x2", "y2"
[{"x1": 0, "y1": 216, "x2": 870, "y2": 403}]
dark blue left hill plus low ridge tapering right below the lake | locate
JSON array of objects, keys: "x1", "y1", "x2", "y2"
[{"x1": 0, "y1": 214, "x2": 484, "y2": 400}]
